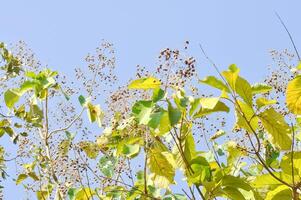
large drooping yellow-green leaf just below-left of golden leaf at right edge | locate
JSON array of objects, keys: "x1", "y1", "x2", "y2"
[{"x1": 259, "y1": 108, "x2": 292, "y2": 150}]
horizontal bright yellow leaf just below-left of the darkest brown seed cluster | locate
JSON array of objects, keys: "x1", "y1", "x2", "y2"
[{"x1": 128, "y1": 77, "x2": 161, "y2": 90}]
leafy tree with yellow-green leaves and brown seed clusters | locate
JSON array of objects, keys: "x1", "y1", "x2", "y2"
[{"x1": 0, "y1": 43, "x2": 301, "y2": 200}]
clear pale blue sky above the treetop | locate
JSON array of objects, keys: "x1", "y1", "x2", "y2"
[{"x1": 0, "y1": 0, "x2": 301, "y2": 199}]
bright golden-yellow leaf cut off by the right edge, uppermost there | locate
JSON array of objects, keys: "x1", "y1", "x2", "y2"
[{"x1": 286, "y1": 75, "x2": 301, "y2": 114}]
